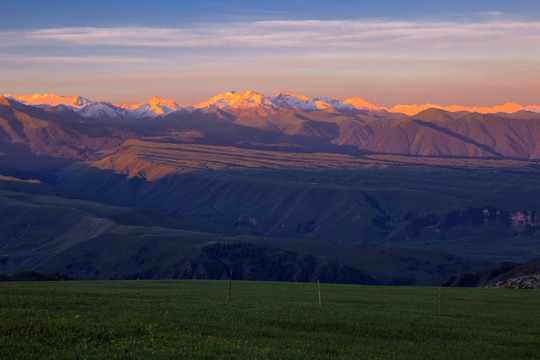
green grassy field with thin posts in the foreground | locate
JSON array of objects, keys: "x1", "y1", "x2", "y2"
[{"x1": 0, "y1": 281, "x2": 540, "y2": 359}]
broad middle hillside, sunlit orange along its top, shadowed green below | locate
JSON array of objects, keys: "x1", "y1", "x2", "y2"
[{"x1": 53, "y1": 142, "x2": 540, "y2": 261}]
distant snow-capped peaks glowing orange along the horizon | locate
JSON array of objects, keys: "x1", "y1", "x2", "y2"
[{"x1": 4, "y1": 90, "x2": 540, "y2": 118}]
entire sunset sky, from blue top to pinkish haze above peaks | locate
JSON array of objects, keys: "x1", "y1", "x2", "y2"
[{"x1": 0, "y1": 0, "x2": 540, "y2": 107}]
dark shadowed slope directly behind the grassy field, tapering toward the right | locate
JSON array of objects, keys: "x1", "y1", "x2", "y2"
[{"x1": 0, "y1": 179, "x2": 483, "y2": 284}]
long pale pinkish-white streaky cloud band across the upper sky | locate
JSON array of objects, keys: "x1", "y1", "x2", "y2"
[{"x1": 0, "y1": 19, "x2": 540, "y2": 51}]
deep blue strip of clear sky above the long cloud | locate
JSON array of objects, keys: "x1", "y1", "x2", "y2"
[{"x1": 4, "y1": 0, "x2": 540, "y2": 29}]
